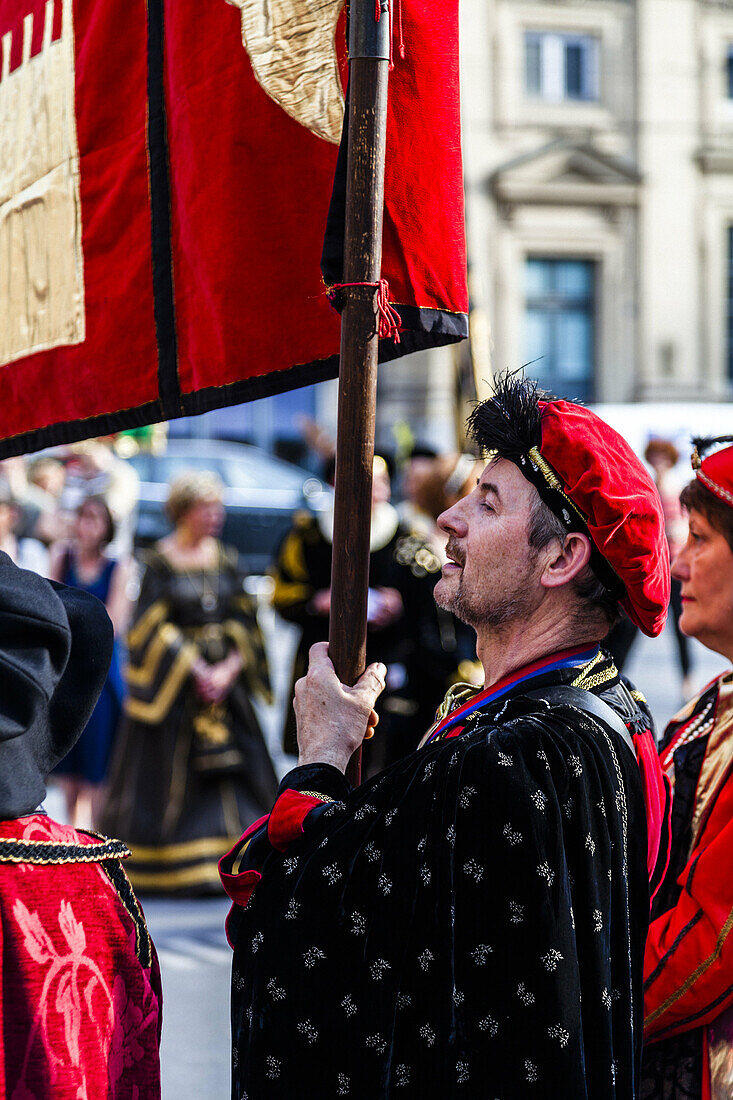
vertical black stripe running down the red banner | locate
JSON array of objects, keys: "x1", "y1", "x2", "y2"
[{"x1": 147, "y1": 0, "x2": 183, "y2": 420}]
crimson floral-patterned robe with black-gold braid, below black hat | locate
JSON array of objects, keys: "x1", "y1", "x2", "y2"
[{"x1": 0, "y1": 814, "x2": 162, "y2": 1100}]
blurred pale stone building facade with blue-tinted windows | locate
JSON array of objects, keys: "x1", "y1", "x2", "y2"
[{"x1": 462, "y1": 0, "x2": 733, "y2": 402}]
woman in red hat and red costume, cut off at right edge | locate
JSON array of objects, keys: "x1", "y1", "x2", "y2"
[{"x1": 641, "y1": 436, "x2": 733, "y2": 1100}]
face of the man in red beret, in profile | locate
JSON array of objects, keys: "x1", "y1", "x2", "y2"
[{"x1": 435, "y1": 459, "x2": 543, "y2": 630}]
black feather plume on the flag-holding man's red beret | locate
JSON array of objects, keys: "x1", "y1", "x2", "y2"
[{"x1": 467, "y1": 371, "x2": 548, "y2": 462}]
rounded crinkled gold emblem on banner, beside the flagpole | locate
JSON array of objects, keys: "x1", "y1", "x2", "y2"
[{"x1": 227, "y1": 0, "x2": 343, "y2": 145}]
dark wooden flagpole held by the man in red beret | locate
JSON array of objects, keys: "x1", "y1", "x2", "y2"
[{"x1": 329, "y1": 0, "x2": 390, "y2": 784}]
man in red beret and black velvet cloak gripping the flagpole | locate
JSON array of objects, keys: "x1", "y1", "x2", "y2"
[{"x1": 221, "y1": 376, "x2": 669, "y2": 1100}]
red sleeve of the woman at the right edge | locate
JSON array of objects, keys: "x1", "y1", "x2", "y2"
[{"x1": 644, "y1": 776, "x2": 733, "y2": 1041}]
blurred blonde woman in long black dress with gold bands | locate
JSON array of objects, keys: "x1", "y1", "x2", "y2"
[{"x1": 103, "y1": 473, "x2": 277, "y2": 894}]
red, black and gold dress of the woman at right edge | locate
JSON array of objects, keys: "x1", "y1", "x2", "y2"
[{"x1": 641, "y1": 672, "x2": 733, "y2": 1100}]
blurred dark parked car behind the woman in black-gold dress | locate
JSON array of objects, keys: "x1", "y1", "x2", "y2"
[{"x1": 128, "y1": 439, "x2": 332, "y2": 573}]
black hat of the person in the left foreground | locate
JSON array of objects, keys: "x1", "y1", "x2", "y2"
[{"x1": 0, "y1": 552, "x2": 113, "y2": 821}]
